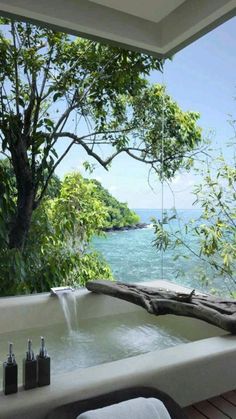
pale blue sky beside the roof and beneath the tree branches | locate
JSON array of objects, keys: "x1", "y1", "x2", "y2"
[{"x1": 56, "y1": 17, "x2": 236, "y2": 209}]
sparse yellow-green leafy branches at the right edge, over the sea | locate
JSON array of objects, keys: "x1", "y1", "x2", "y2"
[{"x1": 154, "y1": 144, "x2": 236, "y2": 296}]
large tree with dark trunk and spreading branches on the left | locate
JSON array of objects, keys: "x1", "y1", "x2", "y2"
[{"x1": 0, "y1": 19, "x2": 201, "y2": 251}]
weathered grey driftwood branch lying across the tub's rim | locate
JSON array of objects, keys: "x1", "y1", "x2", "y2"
[{"x1": 86, "y1": 281, "x2": 236, "y2": 334}]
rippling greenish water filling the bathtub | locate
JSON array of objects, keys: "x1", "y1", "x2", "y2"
[{"x1": 0, "y1": 311, "x2": 189, "y2": 382}]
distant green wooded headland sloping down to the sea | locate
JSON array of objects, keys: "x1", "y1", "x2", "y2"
[{"x1": 93, "y1": 179, "x2": 140, "y2": 228}]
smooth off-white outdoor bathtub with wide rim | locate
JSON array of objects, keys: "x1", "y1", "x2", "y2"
[{"x1": 0, "y1": 282, "x2": 236, "y2": 419}]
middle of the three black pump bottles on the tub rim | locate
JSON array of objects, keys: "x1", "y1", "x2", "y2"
[{"x1": 23, "y1": 339, "x2": 38, "y2": 390}]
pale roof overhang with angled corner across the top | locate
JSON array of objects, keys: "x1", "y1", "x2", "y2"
[{"x1": 0, "y1": 0, "x2": 236, "y2": 57}]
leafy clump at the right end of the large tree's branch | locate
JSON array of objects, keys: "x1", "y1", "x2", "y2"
[{"x1": 128, "y1": 84, "x2": 201, "y2": 179}]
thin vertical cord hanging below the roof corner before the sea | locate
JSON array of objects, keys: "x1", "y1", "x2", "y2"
[{"x1": 160, "y1": 68, "x2": 165, "y2": 281}]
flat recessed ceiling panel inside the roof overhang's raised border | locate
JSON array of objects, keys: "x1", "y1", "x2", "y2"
[{"x1": 90, "y1": 0, "x2": 185, "y2": 23}]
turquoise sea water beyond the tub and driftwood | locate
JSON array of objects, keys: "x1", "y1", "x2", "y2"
[{"x1": 93, "y1": 209, "x2": 229, "y2": 291}]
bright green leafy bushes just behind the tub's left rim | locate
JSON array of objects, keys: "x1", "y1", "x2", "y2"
[{"x1": 0, "y1": 171, "x2": 112, "y2": 295}]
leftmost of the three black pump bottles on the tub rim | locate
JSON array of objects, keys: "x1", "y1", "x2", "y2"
[{"x1": 3, "y1": 343, "x2": 18, "y2": 394}]
